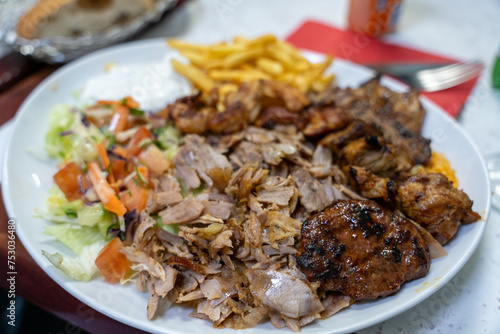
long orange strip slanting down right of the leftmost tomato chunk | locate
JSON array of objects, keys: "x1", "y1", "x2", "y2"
[{"x1": 87, "y1": 161, "x2": 127, "y2": 216}]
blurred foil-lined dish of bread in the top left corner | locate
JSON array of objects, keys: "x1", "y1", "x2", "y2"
[{"x1": 0, "y1": 0, "x2": 177, "y2": 63}]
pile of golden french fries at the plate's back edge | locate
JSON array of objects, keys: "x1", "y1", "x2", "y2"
[{"x1": 168, "y1": 35, "x2": 335, "y2": 95}]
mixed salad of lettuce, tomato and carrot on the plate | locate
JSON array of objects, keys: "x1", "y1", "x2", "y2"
[{"x1": 37, "y1": 97, "x2": 182, "y2": 283}]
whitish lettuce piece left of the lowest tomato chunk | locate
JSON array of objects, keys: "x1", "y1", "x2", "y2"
[{"x1": 42, "y1": 240, "x2": 106, "y2": 282}]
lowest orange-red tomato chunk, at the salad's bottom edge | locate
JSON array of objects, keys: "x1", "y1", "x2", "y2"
[{"x1": 95, "y1": 237, "x2": 130, "y2": 284}]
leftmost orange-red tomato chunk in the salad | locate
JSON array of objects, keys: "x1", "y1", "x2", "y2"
[{"x1": 54, "y1": 162, "x2": 90, "y2": 201}]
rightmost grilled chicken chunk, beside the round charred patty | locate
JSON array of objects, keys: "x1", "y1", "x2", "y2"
[{"x1": 397, "y1": 173, "x2": 481, "y2": 244}]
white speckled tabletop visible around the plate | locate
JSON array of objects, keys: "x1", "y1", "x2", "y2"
[{"x1": 0, "y1": 0, "x2": 500, "y2": 334}]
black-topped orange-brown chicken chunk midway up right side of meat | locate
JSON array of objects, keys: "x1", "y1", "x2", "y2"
[{"x1": 339, "y1": 136, "x2": 412, "y2": 176}]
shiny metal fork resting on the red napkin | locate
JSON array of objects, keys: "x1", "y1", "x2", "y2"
[{"x1": 369, "y1": 61, "x2": 483, "y2": 92}]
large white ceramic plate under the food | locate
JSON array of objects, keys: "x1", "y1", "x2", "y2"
[{"x1": 2, "y1": 39, "x2": 490, "y2": 334}]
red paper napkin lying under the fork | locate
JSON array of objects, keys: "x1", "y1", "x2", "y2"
[{"x1": 287, "y1": 21, "x2": 478, "y2": 118}]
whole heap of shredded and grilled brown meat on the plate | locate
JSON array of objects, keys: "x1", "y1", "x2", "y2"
[{"x1": 123, "y1": 77, "x2": 477, "y2": 331}]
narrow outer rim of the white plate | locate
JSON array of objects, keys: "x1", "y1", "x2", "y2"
[{"x1": 1, "y1": 38, "x2": 491, "y2": 333}]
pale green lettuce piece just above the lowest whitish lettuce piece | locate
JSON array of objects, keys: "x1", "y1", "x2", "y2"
[{"x1": 45, "y1": 223, "x2": 105, "y2": 255}]
